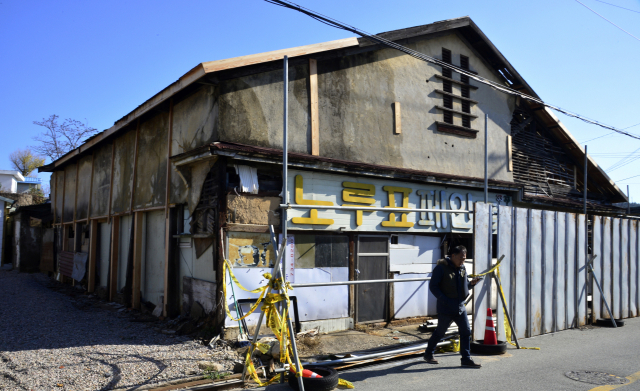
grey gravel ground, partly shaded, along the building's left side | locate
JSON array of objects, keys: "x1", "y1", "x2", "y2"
[{"x1": 0, "y1": 270, "x2": 236, "y2": 391}]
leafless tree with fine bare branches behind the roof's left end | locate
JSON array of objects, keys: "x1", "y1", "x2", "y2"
[{"x1": 31, "y1": 114, "x2": 98, "y2": 161}]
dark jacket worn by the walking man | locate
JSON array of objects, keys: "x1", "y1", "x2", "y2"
[{"x1": 429, "y1": 257, "x2": 469, "y2": 315}]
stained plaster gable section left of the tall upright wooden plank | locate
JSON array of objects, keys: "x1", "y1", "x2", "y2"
[{"x1": 219, "y1": 65, "x2": 311, "y2": 153}]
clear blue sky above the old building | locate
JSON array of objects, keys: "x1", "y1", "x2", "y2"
[{"x1": 0, "y1": 0, "x2": 640, "y2": 202}]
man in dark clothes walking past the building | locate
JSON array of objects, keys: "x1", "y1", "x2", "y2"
[{"x1": 424, "y1": 246, "x2": 481, "y2": 368}]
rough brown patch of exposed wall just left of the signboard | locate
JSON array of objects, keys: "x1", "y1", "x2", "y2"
[{"x1": 227, "y1": 194, "x2": 280, "y2": 226}]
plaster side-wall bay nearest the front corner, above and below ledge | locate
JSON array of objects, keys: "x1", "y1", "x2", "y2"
[{"x1": 170, "y1": 86, "x2": 218, "y2": 204}]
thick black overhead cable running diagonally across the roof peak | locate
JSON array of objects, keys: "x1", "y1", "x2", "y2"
[{"x1": 264, "y1": 0, "x2": 640, "y2": 140}]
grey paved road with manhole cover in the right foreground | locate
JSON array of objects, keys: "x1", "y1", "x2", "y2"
[{"x1": 263, "y1": 318, "x2": 640, "y2": 391}]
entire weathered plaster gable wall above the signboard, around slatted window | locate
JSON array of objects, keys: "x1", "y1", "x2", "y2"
[{"x1": 219, "y1": 33, "x2": 515, "y2": 180}]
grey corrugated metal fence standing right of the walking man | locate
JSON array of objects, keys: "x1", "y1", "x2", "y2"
[{"x1": 473, "y1": 202, "x2": 640, "y2": 340}]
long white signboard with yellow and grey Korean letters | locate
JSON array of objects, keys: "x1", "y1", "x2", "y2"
[{"x1": 287, "y1": 170, "x2": 512, "y2": 233}]
